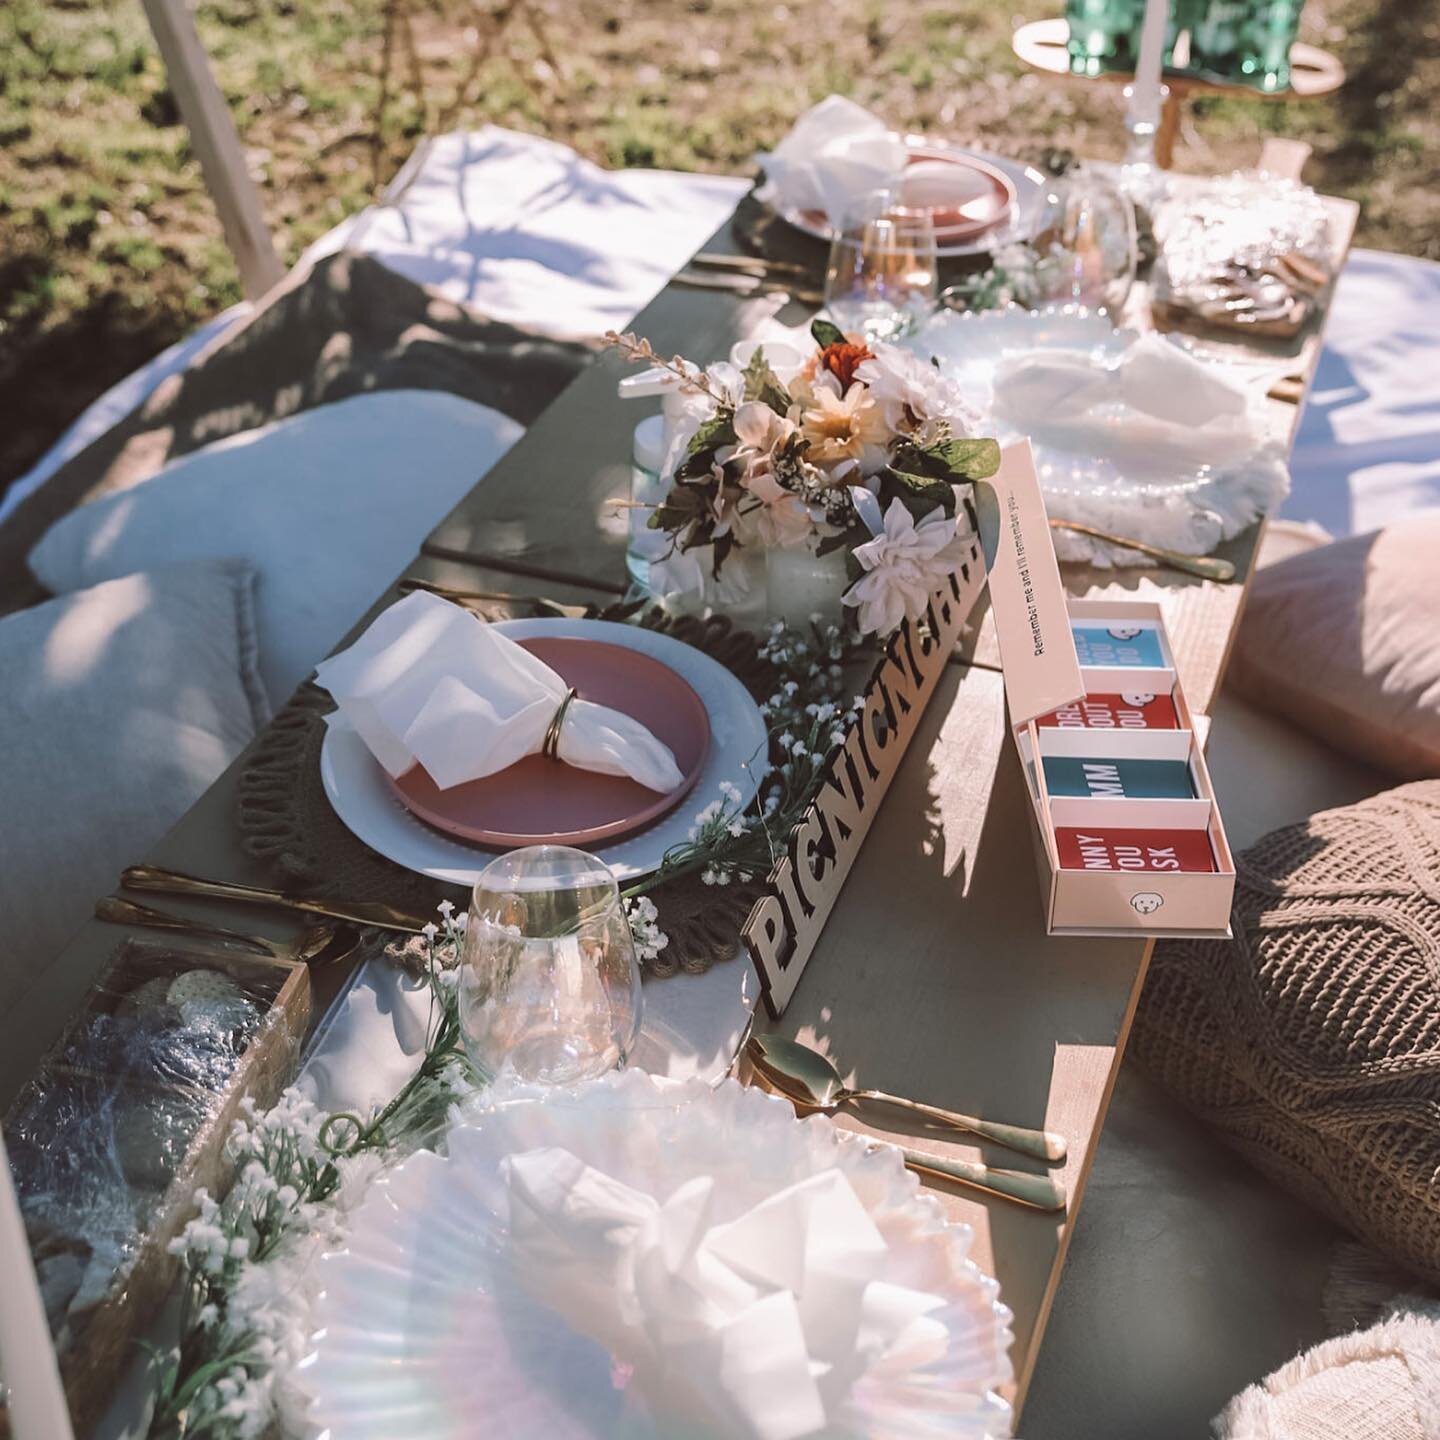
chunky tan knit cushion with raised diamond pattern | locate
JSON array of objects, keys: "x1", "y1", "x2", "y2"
[{"x1": 1130, "y1": 780, "x2": 1440, "y2": 1282}]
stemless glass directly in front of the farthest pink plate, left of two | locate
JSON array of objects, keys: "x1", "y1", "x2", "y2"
[{"x1": 825, "y1": 215, "x2": 939, "y2": 340}]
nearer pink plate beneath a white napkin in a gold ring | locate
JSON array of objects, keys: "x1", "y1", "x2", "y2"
[{"x1": 390, "y1": 636, "x2": 710, "y2": 850}]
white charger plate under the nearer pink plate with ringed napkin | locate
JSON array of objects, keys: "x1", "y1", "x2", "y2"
[{"x1": 320, "y1": 619, "x2": 768, "y2": 886}]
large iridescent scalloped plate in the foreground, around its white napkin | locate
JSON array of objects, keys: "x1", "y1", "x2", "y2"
[{"x1": 298, "y1": 1071, "x2": 1011, "y2": 1440}]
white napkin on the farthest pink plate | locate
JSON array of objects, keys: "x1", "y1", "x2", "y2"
[{"x1": 756, "y1": 95, "x2": 906, "y2": 229}]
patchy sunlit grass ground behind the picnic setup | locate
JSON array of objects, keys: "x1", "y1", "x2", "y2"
[{"x1": 0, "y1": 0, "x2": 1440, "y2": 491}]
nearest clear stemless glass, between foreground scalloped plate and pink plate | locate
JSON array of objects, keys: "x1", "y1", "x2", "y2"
[{"x1": 459, "y1": 845, "x2": 642, "y2": 1084}]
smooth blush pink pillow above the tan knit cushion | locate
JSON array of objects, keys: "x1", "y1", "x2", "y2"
[{"x1": 1228, "y1": 510, "x2": 1440, "y2": 780}]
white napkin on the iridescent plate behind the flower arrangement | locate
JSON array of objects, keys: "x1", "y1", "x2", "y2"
[{"x1": 994, "y1": 333, "x2": 1248, "y2": 426}]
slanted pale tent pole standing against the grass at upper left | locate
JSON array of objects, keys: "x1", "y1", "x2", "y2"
[{"x1": 143, "y1": 0, "x2": 285, "y2": 300}]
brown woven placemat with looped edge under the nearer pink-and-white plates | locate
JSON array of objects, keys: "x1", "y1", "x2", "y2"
[{"x1": 239, "y1": 606, "x2": 775, "y2": 976}]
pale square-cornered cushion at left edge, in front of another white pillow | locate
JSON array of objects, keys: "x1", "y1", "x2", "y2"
[{"x1": 0, "y1": 562, "x2": 269, "y2": 1014}]
